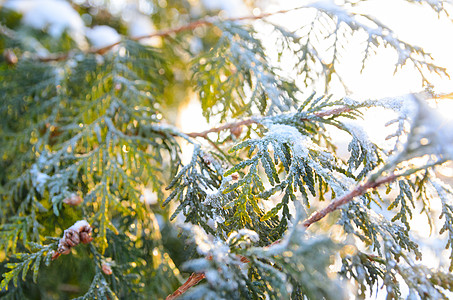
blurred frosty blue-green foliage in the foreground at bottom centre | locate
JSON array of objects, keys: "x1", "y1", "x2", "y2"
[{"x1": 183, "y1": 209, "x2": 344, "y2": 299}]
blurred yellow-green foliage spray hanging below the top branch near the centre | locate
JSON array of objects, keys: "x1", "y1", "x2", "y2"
[{"x1": 192, "y1": 22, "x2": 297, "y2": 121}]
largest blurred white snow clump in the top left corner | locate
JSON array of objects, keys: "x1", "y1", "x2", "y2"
[{"x1": 4, "y1": 0, "x2": 84, "y2": 44}]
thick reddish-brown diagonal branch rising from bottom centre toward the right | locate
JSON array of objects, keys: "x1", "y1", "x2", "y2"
[{"x1": 166, "y1": 173, "x2": 405, "y2": 300}]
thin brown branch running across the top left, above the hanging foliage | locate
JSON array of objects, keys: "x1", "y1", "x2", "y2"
[{"x1": 34, "y1": 6, "x2": 304, "y2": 62}]
